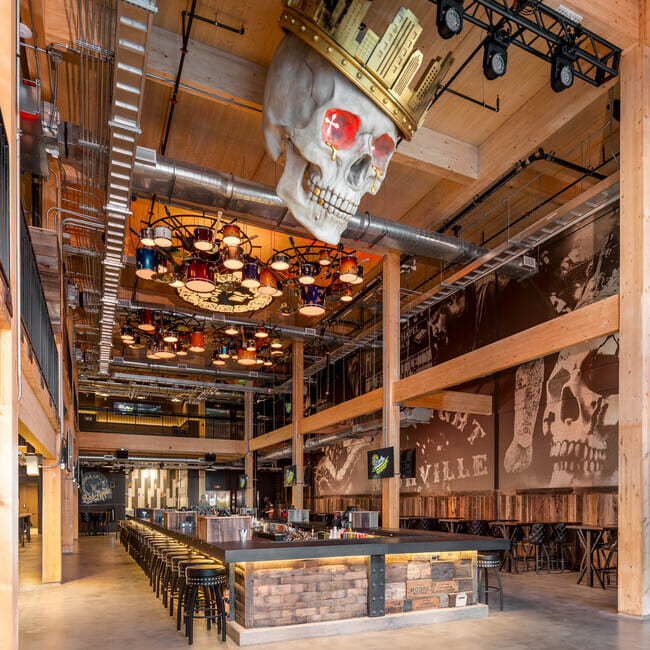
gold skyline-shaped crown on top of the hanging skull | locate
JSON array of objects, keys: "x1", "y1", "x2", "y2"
[{"x1": 280, "y1": 0, "x2": 452, "y2": 140}]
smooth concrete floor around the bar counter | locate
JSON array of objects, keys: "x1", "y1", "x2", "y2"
[{"x1": 19, "y1": 536, "x2": 650, "y2": 650}]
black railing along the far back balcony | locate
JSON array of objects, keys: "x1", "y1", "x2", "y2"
[{"x1": 79, "y1": 407, "x2": 244, "y2": 440}]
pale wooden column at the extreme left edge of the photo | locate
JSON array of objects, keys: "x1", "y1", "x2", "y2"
[{"x1": 0, "y1": 0, "x2": 20, "y2": 650}]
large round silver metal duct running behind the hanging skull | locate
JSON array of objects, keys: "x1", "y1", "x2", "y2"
[{"x1": 133, "y1": 147, "x2": 530, "y2": 276}]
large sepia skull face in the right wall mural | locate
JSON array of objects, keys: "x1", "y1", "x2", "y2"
[{"x1": 544, "y1": 335, "x2": 618, "y2": 485}]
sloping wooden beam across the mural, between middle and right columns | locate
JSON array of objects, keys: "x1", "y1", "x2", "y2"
[{"x1": 394, "y1": 295, "x2": 618, "y2": 403}]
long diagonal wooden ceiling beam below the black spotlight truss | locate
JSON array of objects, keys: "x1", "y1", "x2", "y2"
[{"x1": 400, "y1": 74, "x2": 613, "y2": 228}]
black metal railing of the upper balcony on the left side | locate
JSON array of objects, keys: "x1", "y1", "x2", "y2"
[{"x1": 20, "y1": 211, "x2": 59, "y2": 408}]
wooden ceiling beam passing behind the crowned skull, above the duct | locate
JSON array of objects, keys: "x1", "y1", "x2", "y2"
[{"x1": 147, "y1": 26, "x2": 479, "y2": 182}]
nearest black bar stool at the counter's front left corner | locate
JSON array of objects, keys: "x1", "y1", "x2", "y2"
[{"x1": 185, "y1": 564, "x2": 226, "y2": 645}]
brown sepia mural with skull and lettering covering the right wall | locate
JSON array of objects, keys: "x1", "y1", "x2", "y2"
[{"x1": 308, "y1": 211, "x2": 619, "y2": 495}]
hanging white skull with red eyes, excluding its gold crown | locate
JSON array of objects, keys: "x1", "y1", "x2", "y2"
[{"x1": 263, "y1": 34, "x2": 397, "y2": 245}]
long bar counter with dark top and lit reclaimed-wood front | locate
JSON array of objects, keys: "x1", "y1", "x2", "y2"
[{"x1": 130, "y1": 519, "x2": 510, "y2": 645}]
